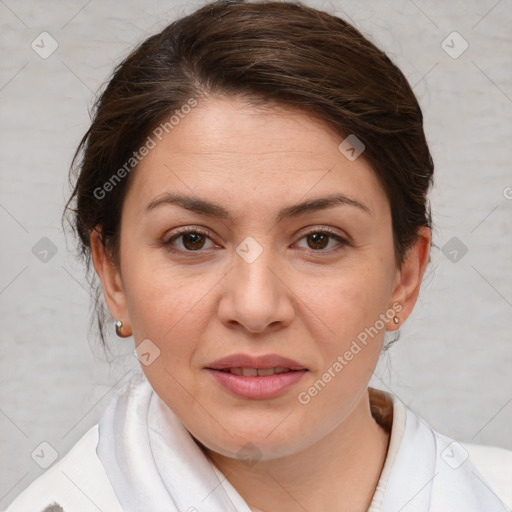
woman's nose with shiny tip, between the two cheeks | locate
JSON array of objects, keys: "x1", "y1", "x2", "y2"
[{"x1": 218, "y1": 242, "x2": 295, "y2": 334}]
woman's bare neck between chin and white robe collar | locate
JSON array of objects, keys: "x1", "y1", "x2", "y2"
[{"x1": 208, "y1": 391, "x2": 389, "y2": 512}]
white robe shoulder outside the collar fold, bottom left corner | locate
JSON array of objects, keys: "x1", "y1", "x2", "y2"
[{"x1": 6, "y1": 425, "x2": 122, "y2": 512}]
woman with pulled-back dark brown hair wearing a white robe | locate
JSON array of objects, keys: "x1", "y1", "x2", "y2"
[{"x1": 8, "y1": 1, "x2": 511, "y2": 512}]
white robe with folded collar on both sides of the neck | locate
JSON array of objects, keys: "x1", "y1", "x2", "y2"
[{"x1": 6, "y1": 376, "x2": 512, "y2": 512}]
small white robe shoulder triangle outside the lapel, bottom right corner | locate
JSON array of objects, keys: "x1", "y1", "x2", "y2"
[{"x1": 460, "y1": 443, "x2": 512, "y2": 507}]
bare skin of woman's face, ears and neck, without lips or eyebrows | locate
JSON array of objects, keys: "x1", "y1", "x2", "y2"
[{"x1": 91, "y1": 97, "x2": 430, "y2": 512}]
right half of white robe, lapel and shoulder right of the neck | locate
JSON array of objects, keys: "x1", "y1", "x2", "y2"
[{"x1": 379, "y1": 390, "x2": 512, "y2": 512}]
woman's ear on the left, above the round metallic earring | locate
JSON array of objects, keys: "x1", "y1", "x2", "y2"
[{"x1": 89, "y1": 229, "x2": 130, "y2": 329}]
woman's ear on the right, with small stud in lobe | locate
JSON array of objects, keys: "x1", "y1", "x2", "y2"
[{"x1": 387, "y1": 227, "x2": 432, "y2": 331}]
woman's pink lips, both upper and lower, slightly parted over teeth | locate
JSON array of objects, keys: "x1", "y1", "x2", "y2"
[{"x1": 205, "y1": 354, "x2": 309, "y2": 400}]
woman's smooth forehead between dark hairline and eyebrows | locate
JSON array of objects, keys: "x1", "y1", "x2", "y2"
[{"x1": 126, "y1": 98, "x2": 388, "y2": 221}]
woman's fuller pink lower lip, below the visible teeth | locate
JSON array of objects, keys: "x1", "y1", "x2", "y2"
[{"x1": 207, "y1": 368, "x2": 307, "y2": 400}]
